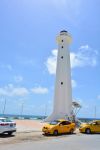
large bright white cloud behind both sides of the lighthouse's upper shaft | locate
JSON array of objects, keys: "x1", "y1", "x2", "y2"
[{"x1": 46, "y1": 45, "x2": 98, "y2": 74}]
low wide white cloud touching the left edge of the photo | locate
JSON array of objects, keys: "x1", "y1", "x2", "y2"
[{"x1": 0, "y1": 84, "x2": 29, "y2": 97}]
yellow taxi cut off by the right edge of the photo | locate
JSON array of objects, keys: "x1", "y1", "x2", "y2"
[{"x1": 79, "y1": 120, "x2": 100, "y2": 134}]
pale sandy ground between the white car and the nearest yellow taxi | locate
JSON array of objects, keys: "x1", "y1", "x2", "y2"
[{"x1": 0, "y1": 120, "x2": 79, "y2": 145}]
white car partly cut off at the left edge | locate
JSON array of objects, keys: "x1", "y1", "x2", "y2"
[{"x1": 0, "y1": 118, "x2": 16, "y2": 135}]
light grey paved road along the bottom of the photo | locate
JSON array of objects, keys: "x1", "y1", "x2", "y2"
[{"x1": 0, "y1": 134, "x2": 100, "y2": 150}]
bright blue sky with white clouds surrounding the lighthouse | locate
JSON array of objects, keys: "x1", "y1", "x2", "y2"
[{"x1": 0, "y1": 0, "x2": 100, "y2": 117}]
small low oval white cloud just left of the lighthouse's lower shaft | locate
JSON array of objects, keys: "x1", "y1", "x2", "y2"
[{"x1": 31, "y1": 86, "x2": 48, "y2": 94}]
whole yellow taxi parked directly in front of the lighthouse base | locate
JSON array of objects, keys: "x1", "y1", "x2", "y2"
[{"x1": 42, "y1": 119, "x2": 75, "y2": 135}]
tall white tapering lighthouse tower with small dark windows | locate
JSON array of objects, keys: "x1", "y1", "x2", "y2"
[{"x1": 46, "y1": 30, "x2": 72, "y2": 121}]
